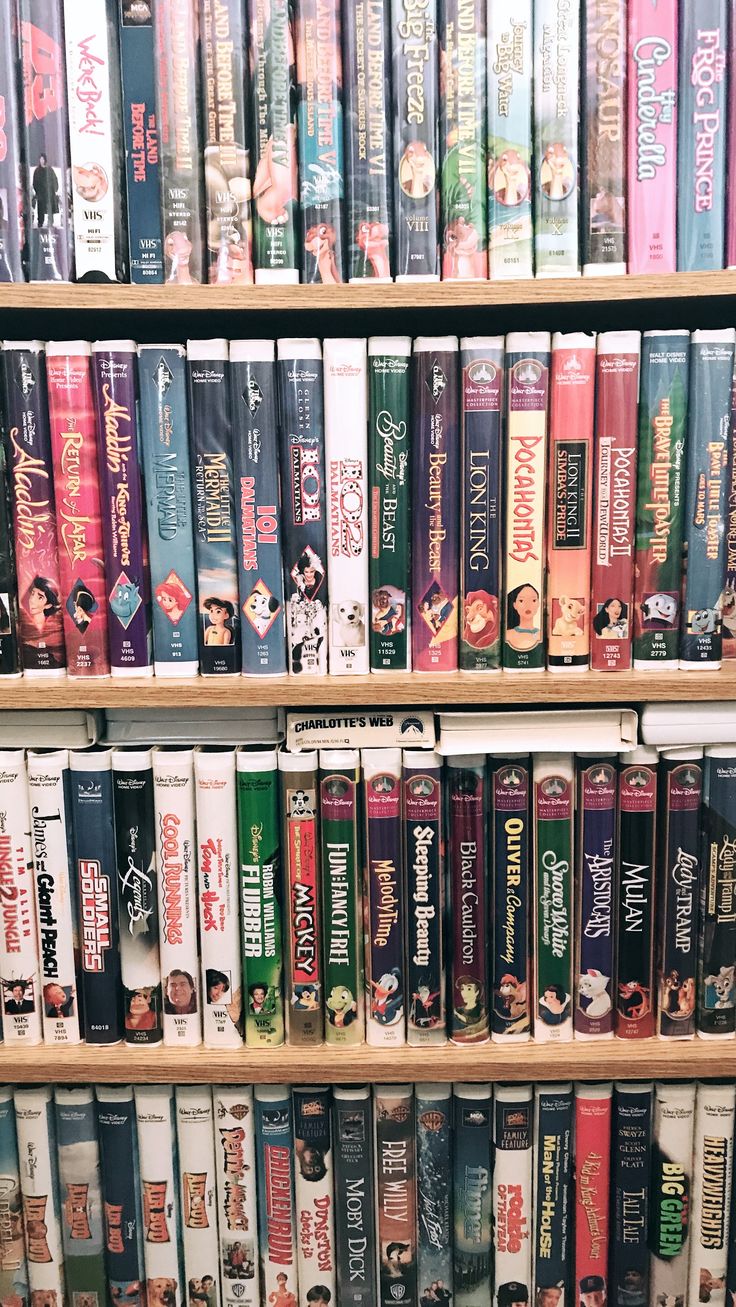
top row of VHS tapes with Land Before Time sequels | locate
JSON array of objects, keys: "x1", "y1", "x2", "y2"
[{"x1": 0, "y1": 0, "x2": 736, "y2": 285}]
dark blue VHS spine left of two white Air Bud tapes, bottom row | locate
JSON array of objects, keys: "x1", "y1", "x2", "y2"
[{"x1": 95, "y1": 1085, "x2": 145, "y2": 1304}]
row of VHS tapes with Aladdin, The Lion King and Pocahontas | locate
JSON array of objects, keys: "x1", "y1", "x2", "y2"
[{"x1": 0, "y1": 328, "x2": 736, "y2": 677}]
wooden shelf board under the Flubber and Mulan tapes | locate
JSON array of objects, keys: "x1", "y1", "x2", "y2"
[{"x1": 0, "y1": 1039, "x2": 736, "y2": 1085}]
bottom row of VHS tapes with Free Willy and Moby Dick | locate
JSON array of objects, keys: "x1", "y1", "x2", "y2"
[{"x1": 0, "y1": 1082, "x2": 736, "y2": 1307}]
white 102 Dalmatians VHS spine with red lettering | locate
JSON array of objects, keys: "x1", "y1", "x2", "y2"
[{"x1": 324, "y1": 340, "x2": 370, "y2": 676}]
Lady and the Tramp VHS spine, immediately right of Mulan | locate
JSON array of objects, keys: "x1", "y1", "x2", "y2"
[{"x1": 656, "y1": 749, "x2": 703, "y2": 1039}]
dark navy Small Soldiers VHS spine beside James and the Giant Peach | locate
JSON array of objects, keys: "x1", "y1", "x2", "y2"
[{"x1": 69, "y1": 750, "x2": 123, "y2": 1044}]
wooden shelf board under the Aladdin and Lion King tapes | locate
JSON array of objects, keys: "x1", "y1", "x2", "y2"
[{"x1": 0, "y1": 660, "x2": 736, "y2": 711}]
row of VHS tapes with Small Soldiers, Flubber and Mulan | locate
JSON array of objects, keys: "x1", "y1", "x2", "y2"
[{"x1": 0, "y1": 745, "x2": 736, "y2": 1056}]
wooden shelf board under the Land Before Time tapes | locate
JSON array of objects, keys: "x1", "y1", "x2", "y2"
[{"x1": 0, "y1": 271, "x2": 736, "y2": 312}]
